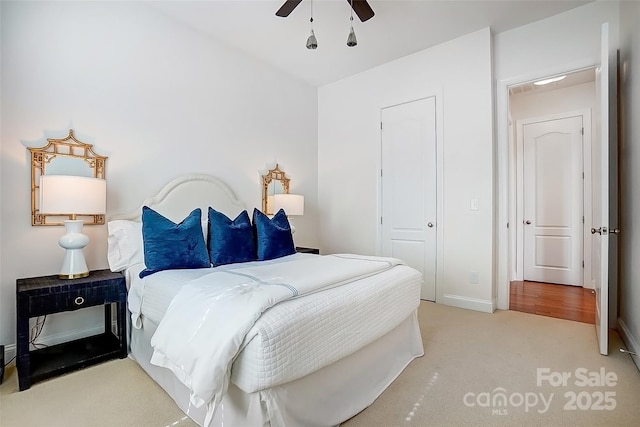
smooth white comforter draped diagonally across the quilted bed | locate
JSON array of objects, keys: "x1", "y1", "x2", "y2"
[{"x1": 151, "y1": 255, "x2": 402, "y2": 425}]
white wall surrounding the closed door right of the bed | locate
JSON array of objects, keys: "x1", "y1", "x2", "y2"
[{"x1": 318, "y1": 28, "x2": 494, "y2": 311}]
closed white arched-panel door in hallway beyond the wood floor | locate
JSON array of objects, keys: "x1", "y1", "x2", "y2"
[{"x1": 518, "y1": 115, "x2": 584, "y2": 286}]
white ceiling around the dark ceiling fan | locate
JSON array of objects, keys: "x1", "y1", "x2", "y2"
[{"x1": 145, "y1": 0, "x2": 593, "y2": 86}]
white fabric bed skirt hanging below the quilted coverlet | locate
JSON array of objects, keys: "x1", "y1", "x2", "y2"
[{"x1": 130, "y1": 311, "x2": 424, "y2": 427}]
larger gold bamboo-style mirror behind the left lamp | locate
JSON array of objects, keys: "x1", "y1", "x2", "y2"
[{"x1": 28, "y1": 129, "x2": 107, "y2": 225}]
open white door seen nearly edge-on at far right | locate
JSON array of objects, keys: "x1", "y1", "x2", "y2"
[{"x1": 591, "y1": 23, "x2": 615, "y2": 355}]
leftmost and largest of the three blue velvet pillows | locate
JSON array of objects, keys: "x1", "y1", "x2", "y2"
[{"x1": 140, "y1": 206, "x2": 211, "y2": 278}]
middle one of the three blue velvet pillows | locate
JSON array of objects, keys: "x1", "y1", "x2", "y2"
[{"x1": 209, "y1": 207, "x2": 256, "y2": 267}]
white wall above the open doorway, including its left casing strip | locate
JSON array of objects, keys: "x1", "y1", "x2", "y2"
[{"x1": 494, "y1": 1, "x2": 619, "y2": 309}]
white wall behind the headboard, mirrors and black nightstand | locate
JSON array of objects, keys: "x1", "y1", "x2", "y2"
[{"x1": 0, "y1": 2, "x2": 318, "y2": 352}]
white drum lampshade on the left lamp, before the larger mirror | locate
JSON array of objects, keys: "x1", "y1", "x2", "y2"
[{"x1": 40, "y1": 175, "x2": 107, "y2": 215}]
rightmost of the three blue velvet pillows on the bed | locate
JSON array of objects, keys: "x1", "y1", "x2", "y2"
[{"x1": 253, "y1": 209, "x2": 296, "y2": 261}]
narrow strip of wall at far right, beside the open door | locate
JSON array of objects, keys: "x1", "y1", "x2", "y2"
[{"x1": 618, "y1": 1, "x2": 640, "y2": 367}]
